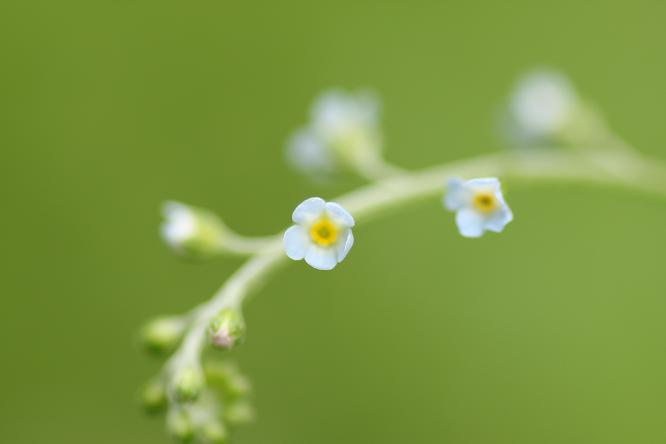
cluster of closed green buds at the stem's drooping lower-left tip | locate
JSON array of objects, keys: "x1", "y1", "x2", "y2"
[{"x1": 142, "y1": 307, "x2": 254, "y2": 444}]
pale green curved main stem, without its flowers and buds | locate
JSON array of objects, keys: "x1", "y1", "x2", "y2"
[{"x1": 171, "y1": 150, "x2": 666, "y2": 374}]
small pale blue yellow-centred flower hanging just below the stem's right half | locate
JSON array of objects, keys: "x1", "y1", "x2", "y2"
[{"x1": 444, "y1": 177, "x2": 513, "y2": 237}]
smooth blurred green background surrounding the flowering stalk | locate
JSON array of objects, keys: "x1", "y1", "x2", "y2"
[{"x1": 0, "y1": 0, "x2": 666, "y2": 444}]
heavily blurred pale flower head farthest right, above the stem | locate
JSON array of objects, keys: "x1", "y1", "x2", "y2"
[{"x1": 509, "y1": 70, "x2": 577, "y2": 139}]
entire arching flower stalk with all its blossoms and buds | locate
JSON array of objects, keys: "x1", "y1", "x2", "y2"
[{"x1": 139, "y1": 78, "x2": 666, "y2": 442}]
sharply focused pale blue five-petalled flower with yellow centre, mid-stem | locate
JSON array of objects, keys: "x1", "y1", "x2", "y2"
[{"x1": 284, "y1": 197, "x2": 354, "y2": 270}]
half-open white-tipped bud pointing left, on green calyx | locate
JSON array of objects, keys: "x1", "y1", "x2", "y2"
[{"x1": 162, "y1": 201, "x2": 227, "y2": 258}]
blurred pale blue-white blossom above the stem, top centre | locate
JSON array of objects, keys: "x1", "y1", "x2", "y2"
[{"x1": 287, "y1": 90, "x2": 381, "y2": 174}]
